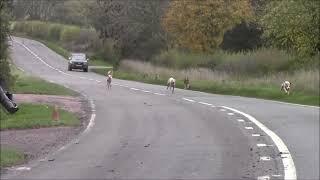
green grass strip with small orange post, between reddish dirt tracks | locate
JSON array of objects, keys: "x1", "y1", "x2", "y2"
[{"x1": 0, "y1": 104, "x2": 80, "y2": 130}]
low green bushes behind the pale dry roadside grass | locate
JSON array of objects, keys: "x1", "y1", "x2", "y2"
[{"x1": 151, "y1": 48, "x2": 295, "y2": 75}]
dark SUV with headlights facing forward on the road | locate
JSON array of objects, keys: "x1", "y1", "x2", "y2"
[{"x1": 68, "y1": 53, "x2": 89, "y2": 72}]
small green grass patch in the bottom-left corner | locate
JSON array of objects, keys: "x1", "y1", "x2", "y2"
[{"x1": 0, "y1": 146, "x2": 25, "y2": 168}]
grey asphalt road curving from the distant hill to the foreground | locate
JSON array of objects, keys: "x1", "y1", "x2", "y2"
[{"x1": 2, "y1": 38, "x2": 319, "y2": 179}]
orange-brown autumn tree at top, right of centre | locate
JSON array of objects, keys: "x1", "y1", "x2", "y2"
[{"x1": 163, "y1": 0, "x2": 252, "y2": 51}]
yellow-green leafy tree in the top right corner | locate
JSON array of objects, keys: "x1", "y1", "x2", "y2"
[{"x1": 260, "y1": 0, "x2": 320, "y2": 56}]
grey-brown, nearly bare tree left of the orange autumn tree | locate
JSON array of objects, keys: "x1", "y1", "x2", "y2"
[{"x1": 85, "y1": 0, "x2": 167, "y2": 59}]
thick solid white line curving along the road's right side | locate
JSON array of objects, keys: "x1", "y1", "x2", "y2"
[{"x1": 222, "y1": 106, "x2": 297, "y2": 180}]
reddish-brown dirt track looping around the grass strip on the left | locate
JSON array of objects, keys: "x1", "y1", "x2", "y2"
[{"x1": 0, "y1": 94, "x2": 91, "y2": 167}]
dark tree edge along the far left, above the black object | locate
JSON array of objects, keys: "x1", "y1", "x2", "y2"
[{"x1": 0, "y1": 0, "x2": 13, "y2": 89}]
